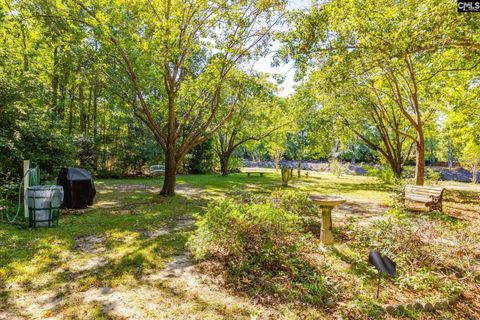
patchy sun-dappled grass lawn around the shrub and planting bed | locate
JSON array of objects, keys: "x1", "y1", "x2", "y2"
[{"x1": 0, "y1": 172, "x2": 480, "y2": 319}]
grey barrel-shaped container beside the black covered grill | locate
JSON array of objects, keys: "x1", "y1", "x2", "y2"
[{"x1": 27, "y1": 186, "x2": 63, "y2": 228}]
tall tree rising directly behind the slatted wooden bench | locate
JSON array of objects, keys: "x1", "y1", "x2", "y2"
[{"x1": 280, "y1": 0, "x2": 480, "y2": 185}]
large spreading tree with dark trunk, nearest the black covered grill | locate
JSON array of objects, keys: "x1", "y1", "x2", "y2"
[{"x1": 52, "y1": 0, "x2": 284, "y2": 196}]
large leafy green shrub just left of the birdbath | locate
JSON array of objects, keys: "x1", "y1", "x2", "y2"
[{"x1": 189, "y1": 194, "x2": 332, "y2": 304}]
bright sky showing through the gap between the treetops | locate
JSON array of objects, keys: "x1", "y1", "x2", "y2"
[{"x1": 253, "y1": 0, "x2": 310, "y2": 97}]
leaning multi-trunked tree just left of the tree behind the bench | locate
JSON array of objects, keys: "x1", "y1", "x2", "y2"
[{"x1": 306, "y1": 70, "x2": 414, "y2": 180}]
